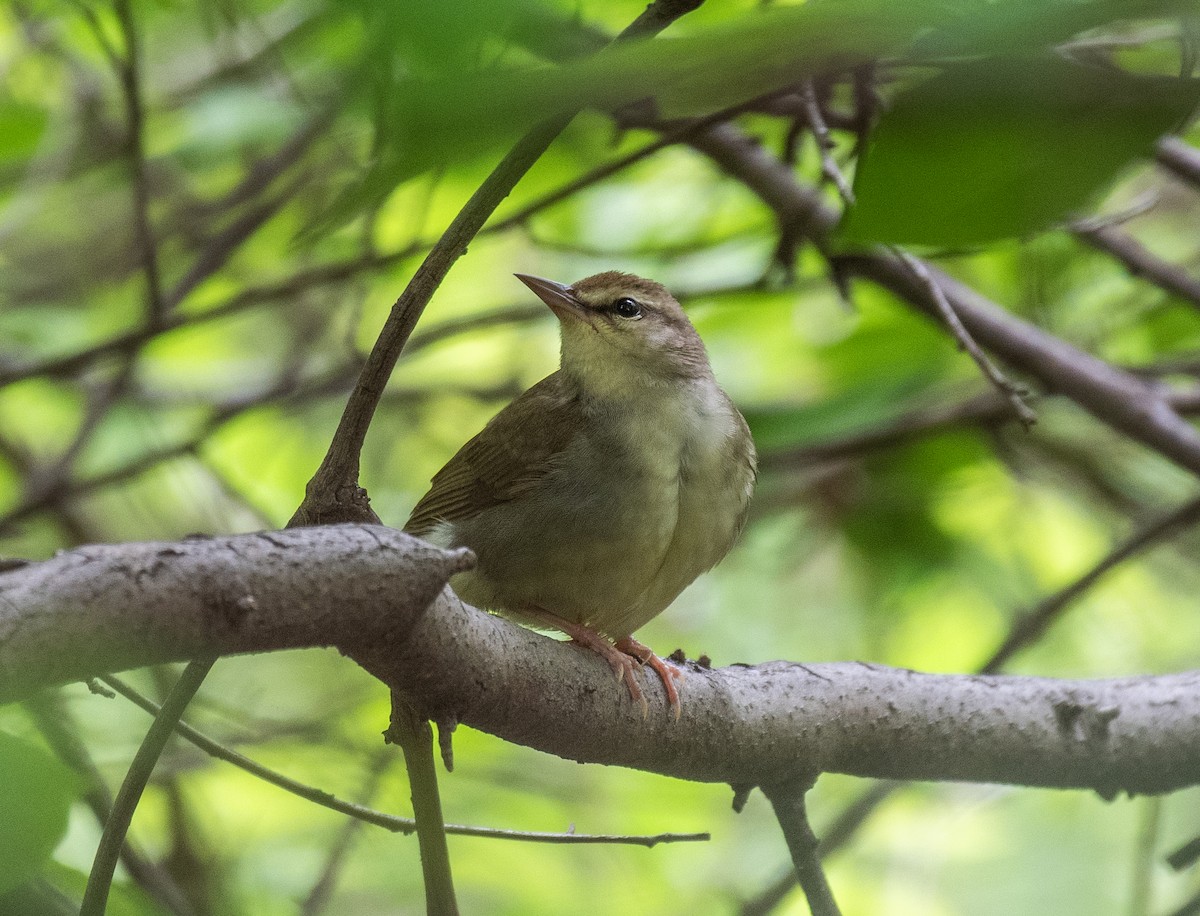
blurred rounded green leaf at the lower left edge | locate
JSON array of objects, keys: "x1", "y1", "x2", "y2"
[{"x1": 0, "y1": 732, "x2": 78, "y2": 894}]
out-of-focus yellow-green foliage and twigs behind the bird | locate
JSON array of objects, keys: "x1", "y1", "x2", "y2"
[{"x1": 0, "y1": 0, "x2": 1200, "y2": 916}]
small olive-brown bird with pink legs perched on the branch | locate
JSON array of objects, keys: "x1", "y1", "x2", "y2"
[{"x1": 404, "y1": 270, "x2": 757, "y2": 720}]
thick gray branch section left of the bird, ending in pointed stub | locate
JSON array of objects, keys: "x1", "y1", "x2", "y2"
[{"x1": 0, "y1": 525, "x2": 470, "y2": 702}]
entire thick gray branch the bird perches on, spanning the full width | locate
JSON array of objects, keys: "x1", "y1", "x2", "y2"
[{"x1": 0, "y1": 526, "x2": 1200, "y2": 796}]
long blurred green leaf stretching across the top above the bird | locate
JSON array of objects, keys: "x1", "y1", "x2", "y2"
[{"x1": 341, "y1": 0, "x2": 1184, "y2": 201}]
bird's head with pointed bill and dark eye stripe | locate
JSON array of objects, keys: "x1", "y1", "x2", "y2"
[{"x1": 516, "y1": 270, "x2": 712, "y2": 389}]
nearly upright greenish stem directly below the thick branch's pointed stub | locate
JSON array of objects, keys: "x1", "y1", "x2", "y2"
[{"x1": 386, "y1": 690, "x2": 458, "y2": 916}]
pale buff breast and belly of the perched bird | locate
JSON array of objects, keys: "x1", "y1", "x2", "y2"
[{"x1": 445, "y1": 382, "x2": 754, "y2": 637}]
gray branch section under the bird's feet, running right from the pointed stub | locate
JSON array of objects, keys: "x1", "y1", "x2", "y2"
[{"x1": 360, "y1": 597, "x2": 1200, "y2": 795}]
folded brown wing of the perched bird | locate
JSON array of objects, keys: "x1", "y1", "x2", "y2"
[{"x1": 404, "y1": 372, "x2": 580, "y2": 537}]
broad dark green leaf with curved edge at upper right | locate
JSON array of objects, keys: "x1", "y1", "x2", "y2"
[{"x1": 841, "y1": 55, "x2": 1200, "y2": 246}]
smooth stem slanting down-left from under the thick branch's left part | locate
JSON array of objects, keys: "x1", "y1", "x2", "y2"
[{"x1": 79, "y1": 659, "x2": 215, "y2": 916}]
